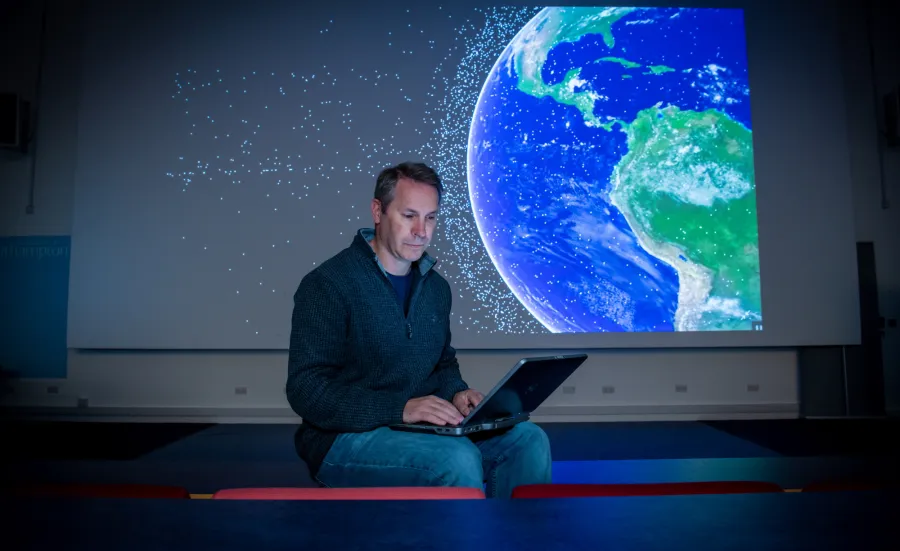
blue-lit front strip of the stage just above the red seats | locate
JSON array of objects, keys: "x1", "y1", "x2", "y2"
[{"x1": 17, "y1": 457, "x2": 900, "y2": 494}]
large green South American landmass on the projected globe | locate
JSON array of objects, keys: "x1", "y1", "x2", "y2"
[{"x1": 611, "y1": 106, "x2": 761, "y2": 330}]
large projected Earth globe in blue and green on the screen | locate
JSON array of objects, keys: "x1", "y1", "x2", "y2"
[{"x1": 467, "y1": 8, "x2": 762, "y2": 332}]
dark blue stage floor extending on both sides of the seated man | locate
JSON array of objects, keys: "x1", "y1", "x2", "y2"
[{"x1": 2, "y1": 419, "x2": 900, "y2": 496}]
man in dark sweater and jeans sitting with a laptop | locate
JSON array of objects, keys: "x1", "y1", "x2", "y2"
[{"x1": 286, "y1": 163, "x2": 551, "y2": 497}]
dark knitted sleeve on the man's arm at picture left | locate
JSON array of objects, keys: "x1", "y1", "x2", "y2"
[{"x1": 285, "y1": 271, "x2": 407, "y2": 432}]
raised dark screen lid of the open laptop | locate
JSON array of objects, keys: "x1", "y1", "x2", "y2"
[{"x1": 460, "y1": 354, "x2": 587, "y2": 426}]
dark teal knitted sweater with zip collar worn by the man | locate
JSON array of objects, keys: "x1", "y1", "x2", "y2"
[{"x1": 285, "y1": 229, "x2": 468, "y2": 476}]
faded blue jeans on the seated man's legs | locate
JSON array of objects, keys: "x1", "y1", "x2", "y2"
[{"x1": 316, "y1": 421, "x2": 551, "y2": 497}]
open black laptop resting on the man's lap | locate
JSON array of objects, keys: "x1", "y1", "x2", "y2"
[{"x1": 390, "y1": 354, "x2": 587, "y2": 436}]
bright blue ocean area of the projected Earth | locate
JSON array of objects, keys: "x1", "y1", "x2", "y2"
[{"x1": 469, "y1": 9, "x2": 751, "y2": 332}]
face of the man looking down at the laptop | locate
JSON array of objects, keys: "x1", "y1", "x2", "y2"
[{"x1": 372, "y1": 178, "x2": 438, "y2": 275}]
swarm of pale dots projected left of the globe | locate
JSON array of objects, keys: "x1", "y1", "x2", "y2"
[{"x1": 167, "y1": 8, "x2": 546, "y2": 334}]
